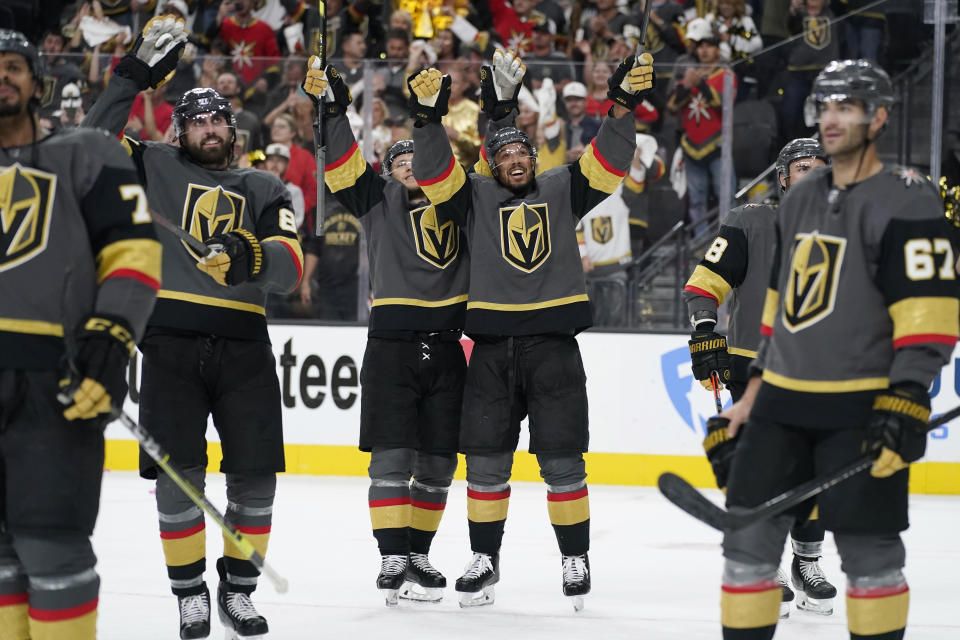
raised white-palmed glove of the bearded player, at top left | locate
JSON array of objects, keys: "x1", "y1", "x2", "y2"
[{"x1": 114, "y1": 16, "x2": 187, "y2": 91}]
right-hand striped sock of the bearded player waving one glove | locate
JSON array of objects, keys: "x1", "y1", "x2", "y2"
[{"x1": 217, "y1": 473, "x2": 277, "y2": 594}]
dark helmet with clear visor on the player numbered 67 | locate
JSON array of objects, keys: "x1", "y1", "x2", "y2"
[{"x1": 803, "y1": 60, "x2": 896, "y2": 127}]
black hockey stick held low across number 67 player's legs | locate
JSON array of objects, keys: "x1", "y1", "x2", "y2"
[{"x1": 657, "y1": 407, "x2": 960, "y2": 531}]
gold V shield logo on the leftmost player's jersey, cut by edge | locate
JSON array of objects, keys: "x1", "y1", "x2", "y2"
[{"x1": 0, "y1": 164, "x2": 57, "y2": 272}]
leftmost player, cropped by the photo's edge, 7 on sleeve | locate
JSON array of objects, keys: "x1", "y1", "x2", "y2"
[{"x1": 0, "y1": 29, "x2": 160, "y2": 640}]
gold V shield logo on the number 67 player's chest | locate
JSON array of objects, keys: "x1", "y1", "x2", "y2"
[{"x1": 783, "y1": 231, "x2": 847, "y2": 333}]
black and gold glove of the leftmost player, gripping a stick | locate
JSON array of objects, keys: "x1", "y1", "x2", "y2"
[{"x1": 58, "y1": 315, "x2": 135, "y2": 420}]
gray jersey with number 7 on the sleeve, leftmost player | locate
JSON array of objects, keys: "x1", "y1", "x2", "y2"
[{"x1": 0, "y1": 130, "x2": 160, "y2": 370}]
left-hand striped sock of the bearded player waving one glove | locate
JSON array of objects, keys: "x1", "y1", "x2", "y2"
[{"x1": 157, "y1": 467, "x2": 207, "y2": 596}]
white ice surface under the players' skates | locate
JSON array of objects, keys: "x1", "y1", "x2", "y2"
[{"x1": 94, "y1": 471, "x2": 960, "y2": 640}]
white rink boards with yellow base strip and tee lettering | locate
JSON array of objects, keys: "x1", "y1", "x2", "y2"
[{"x1": 106, "y1": 325, "x2": 960, "y2": 494}]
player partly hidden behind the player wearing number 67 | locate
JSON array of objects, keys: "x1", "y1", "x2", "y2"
[{"x1": 683, "y1": 138, "x2": 837, "y2": 618}]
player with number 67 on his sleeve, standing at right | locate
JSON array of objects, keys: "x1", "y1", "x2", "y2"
[{"x1": 708, "y1": 60, "x2": 960, "y2": 640}]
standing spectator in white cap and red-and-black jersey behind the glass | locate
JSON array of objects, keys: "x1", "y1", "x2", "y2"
[{"x1": 667, "y1": 21, "x2": 736, "y2": 234}]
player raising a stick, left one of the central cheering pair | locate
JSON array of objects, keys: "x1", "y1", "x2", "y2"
[{"x1": 303, "y1": 56, "x2": 468, "y2": 606}]
